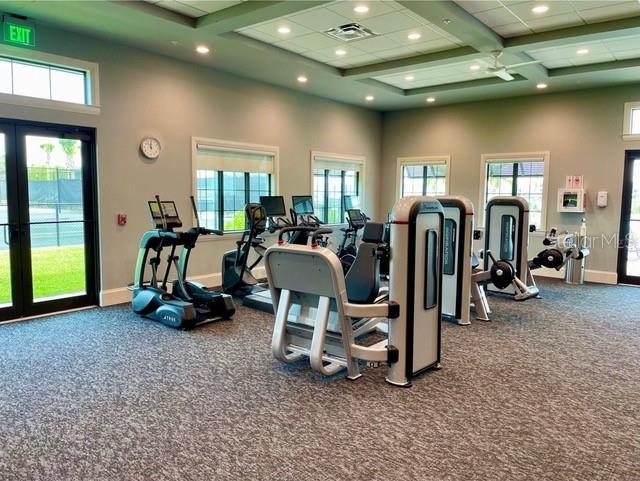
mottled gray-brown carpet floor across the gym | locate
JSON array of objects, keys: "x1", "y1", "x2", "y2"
[{"x1": 0, "y1": 281, "x2": 640, "y2": 481}]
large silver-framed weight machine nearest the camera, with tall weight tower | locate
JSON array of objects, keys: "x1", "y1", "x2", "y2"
[{"x1": 265, "y1": 197, "x2": 444, "y2": 386}]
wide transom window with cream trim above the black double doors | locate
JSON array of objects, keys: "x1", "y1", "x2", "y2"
[{"x1": 0, "y1": 45, "x2": 99, "y2": 113}]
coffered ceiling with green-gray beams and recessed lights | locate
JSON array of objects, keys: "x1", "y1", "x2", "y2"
[{"x1": 0, "y1": 0, "x2": 640, "y2": 110}]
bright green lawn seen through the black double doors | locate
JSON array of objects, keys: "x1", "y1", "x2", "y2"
[{"x1": 0, "y1": 246, "x2": 85, "y2": 304}]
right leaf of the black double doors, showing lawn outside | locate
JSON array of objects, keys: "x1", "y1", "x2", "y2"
[{"x1": 16, "y1": 126, "x2": 96, "y2": 315}]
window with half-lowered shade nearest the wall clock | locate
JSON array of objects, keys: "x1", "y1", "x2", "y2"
[{"x1": 192, "y1": 138, "x2": 278, "y2": 232}]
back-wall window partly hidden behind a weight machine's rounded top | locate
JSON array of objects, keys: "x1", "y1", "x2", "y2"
[{"x1": 482, "y1": 152, "x2": 549, "y2": 230}]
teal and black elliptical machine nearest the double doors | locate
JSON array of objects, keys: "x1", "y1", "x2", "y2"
[{"x1": 131, "y1": 195, "x2": 235, "y2": 329}]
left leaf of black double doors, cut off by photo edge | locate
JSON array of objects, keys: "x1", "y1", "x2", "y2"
[{"x1": 0, "y1": 123, "x2": 22, "y2": 321}]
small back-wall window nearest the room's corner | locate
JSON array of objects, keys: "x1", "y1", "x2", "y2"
[{"x1": 397, "y1": 156, "x2": 449, "y2": 197}]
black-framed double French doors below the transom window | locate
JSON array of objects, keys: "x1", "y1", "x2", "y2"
[{"x1": 0, "y1": 120, "x2": 98, "y2": 321}]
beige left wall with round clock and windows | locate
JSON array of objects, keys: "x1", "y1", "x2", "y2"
[{"x1": 0, "y1": 27, "x2": 381, "y2": 301}]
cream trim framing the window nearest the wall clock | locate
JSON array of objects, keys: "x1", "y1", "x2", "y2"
[{"x1": 191, "y1": 137, "x2": 280, "y2": 242}]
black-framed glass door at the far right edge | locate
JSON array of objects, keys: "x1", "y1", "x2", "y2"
[{"x1": 618, "y1": 150, "x2": 640, "y2": 284}]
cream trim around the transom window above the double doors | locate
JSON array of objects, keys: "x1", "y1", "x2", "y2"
[{"x1": 0, "y1": 45, "x2": 100, "y2": 115}]
